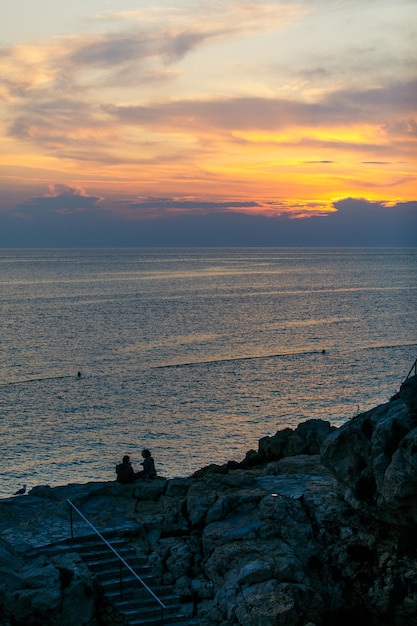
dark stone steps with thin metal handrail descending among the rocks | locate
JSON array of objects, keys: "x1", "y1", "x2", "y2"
[{"x1": 45, "y1": 534, "x2": 198, "y2": 626}]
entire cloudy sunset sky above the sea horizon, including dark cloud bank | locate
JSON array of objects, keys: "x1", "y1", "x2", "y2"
[{"x1": 0, "y1": 0, "x2": 417, "y2": 248}]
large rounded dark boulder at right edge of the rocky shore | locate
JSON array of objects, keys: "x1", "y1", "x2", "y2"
[{"x1": 321, "y1": 397, "x2": 417, "y2": 525}]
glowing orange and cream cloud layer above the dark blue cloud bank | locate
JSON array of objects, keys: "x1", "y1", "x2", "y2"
[{"x1": 0, "y1": 0, "x2": 417, "y2": 216}]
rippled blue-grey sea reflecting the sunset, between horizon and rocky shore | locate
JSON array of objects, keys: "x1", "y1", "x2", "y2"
[{"x1": 0, "y1": 248, "x2": 417, "y2": 498}]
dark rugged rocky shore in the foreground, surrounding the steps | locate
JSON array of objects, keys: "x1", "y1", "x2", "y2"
[{"x1": 0, "y1": 377, "x2": 417, "y2": 626}]
